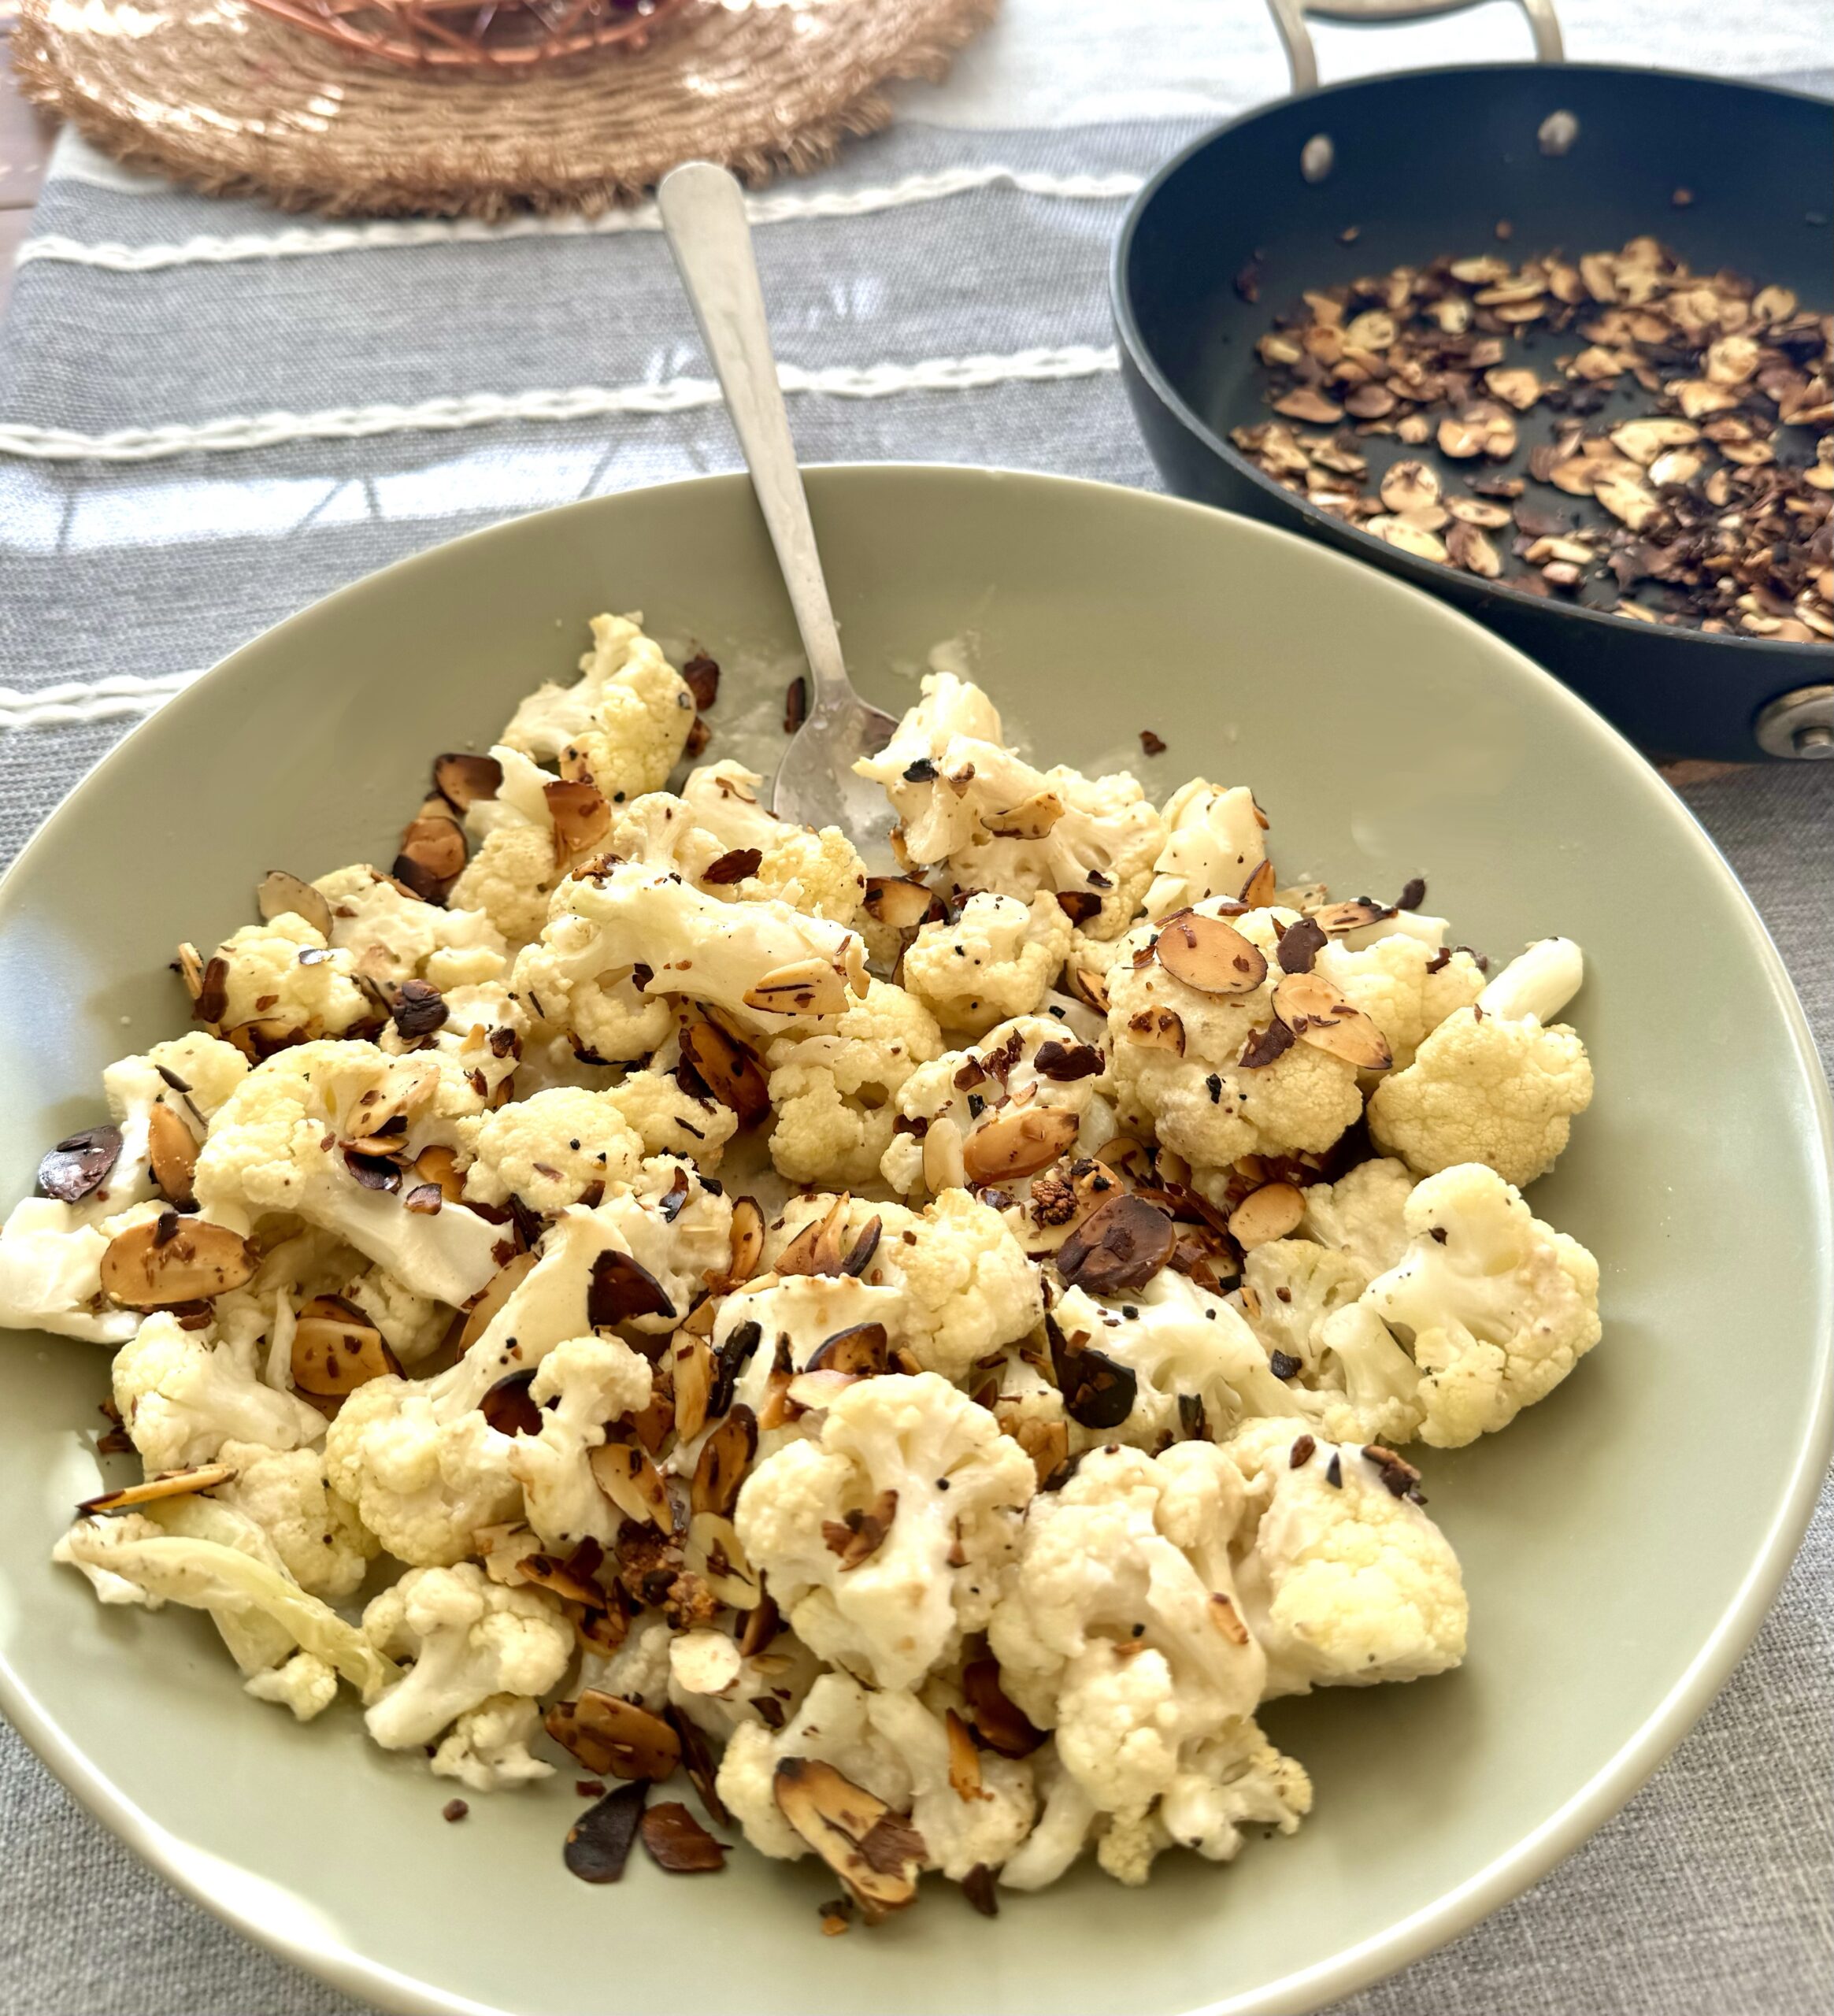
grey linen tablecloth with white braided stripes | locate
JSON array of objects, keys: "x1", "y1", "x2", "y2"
[{"x1": 0, "y1": 0, "x2": 1834, "y2": 2016}]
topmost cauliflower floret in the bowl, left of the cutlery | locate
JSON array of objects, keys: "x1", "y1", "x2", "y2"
[{"x1": 504, "y1": 615, "x2": 695, "y2": 804}]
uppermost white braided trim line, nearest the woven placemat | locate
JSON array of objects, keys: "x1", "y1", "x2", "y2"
[{"x1": 18, "y1": 167, "x2": 1145, "y2": 272}]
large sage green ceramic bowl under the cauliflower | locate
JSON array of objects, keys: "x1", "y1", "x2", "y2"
[{"x1": 0, "y1": 468, "x2": 1834, "y2": 2016}]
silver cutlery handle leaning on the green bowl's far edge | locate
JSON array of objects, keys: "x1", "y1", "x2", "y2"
[{"x1": 657, "y1": 161, "x2": 853, "y2": 713}]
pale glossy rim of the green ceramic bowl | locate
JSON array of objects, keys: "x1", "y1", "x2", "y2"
[{"x1": 0, "y1": 461, "x2": 1834, "y2": 2016}]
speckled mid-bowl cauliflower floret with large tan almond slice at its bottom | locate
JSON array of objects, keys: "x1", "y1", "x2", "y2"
[{"x1": 879, "y1": 1014, "x2": 1114, "y2": 1195}]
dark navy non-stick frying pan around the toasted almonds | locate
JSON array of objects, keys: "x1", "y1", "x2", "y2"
[{"x1": 1113, "y1": 0, "x2": 1834, "y2": 758}]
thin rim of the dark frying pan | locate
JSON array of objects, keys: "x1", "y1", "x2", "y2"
[{"x1": 1109, "y1": 61, "x2": 1834, "y2": 681}]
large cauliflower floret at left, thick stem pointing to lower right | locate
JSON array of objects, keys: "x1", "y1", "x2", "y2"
[{"x1": 195, "y1": 1043, "x2": 502, "y2": 1308}]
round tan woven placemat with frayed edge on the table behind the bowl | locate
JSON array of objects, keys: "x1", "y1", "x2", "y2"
[{"x1": 12, "y1": 0, "x2": 998, "y2": 217}]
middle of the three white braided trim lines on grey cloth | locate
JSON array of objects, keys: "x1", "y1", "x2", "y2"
[{"x1": 0, "y1": 343, "x2": 1118, "y2": 461}]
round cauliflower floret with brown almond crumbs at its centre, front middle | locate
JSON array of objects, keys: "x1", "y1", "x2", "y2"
[{"x1": 734, "y1": 1373, "x2": 1036, "y2": 1688}]
